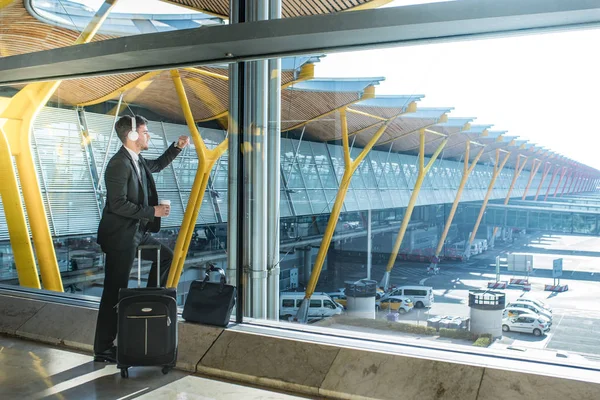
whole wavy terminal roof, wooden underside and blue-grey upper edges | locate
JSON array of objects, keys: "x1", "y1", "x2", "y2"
[{"x1": 0, "y1": 0, "x2": 595, "y2": 176}]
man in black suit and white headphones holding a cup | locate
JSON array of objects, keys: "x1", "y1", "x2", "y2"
[{"x1": 94, "y1": 116, "x2": 189, "y2": 362}]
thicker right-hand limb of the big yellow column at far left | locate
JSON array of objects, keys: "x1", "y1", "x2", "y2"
[{"x1": 0, "y1": 0, "x2": 117, "y2": 291}]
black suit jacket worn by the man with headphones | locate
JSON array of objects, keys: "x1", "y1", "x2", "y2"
[{"x1": 98, "y1": 145, "x2": 181, "y2": 252}]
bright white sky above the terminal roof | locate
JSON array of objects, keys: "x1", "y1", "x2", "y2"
[{"x1": 70, "y1": 0, "x2": 600, "y2": 169}]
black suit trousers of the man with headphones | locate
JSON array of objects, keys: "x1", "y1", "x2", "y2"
[{"x1": 94, "y1": 232, "x2": 173, "y2": 353}]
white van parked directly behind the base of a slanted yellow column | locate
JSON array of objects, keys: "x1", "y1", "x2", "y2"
[{"x1": 279, "y1": 292, "x2": 343, "y2": 320}]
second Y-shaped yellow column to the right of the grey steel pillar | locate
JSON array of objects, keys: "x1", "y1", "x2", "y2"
[{"x1": 380, "y1": 129, "x2": 448, "y2": 290}]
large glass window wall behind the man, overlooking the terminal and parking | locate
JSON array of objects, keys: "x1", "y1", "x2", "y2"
[{"x1": 0, "y1": 0, "x2": 600, "y2": 376}]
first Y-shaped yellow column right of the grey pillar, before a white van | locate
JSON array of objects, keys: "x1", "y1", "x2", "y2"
[{"x1": 296, "y1": 107, "x2": 415, "y2": 322}]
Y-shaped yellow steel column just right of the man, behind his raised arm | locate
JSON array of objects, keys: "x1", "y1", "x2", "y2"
[{"x1": 167, "y1": 70, "x2": 229, "y2": 287}]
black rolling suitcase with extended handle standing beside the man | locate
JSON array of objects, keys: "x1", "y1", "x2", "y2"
[{"x1": 117, "y1": 245, "x2": 177, "y2": 378}]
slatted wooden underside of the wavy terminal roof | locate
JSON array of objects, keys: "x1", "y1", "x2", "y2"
[{"x1": 0, "y1": 0, "x2": 588, "y2": 169}]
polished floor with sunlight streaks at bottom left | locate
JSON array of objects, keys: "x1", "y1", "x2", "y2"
[{"x1": 0, "y1": 336, "x2": 314, "y2": 400}]
